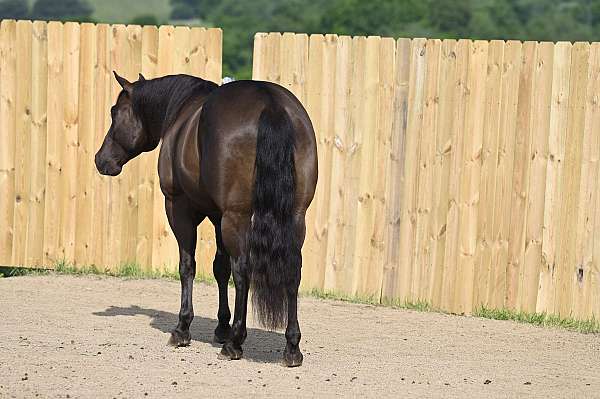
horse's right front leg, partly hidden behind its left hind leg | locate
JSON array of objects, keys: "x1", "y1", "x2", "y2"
[{"x1": 210, "y1": 218, "x2": 231, "y2": 344}]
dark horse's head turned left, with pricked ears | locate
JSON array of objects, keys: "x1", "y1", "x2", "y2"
[{"x1": 96, "y1": 72, "x2": 156, "y2": 176}]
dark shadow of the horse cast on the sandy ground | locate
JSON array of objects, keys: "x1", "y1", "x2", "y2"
[{"x1": 93, "y1": 305, "x2": 285, "y2": 363}]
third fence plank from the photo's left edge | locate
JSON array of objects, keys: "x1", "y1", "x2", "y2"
[{"x1": 25, "y1": 21, "x2": 51, "y2": 267}]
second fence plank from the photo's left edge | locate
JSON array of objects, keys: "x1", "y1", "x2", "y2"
[{"x1": 12, "y1": 21, "x2": 33, "y2": 266}]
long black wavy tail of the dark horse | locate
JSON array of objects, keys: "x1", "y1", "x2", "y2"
[{"x1": 248, "y1": 93, "x2": 302, "y2": 330}]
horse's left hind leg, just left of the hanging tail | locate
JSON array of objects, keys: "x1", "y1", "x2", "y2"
[{"x1": 221, "y1": 212, "x2": 250, "y2": 360}]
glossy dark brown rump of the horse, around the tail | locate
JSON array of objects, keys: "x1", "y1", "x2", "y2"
[{"x1": 199, "y1": 80, "x2": 317, "y2": 213}]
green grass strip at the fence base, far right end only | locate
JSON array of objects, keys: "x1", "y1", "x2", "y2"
[{"x1": 473, "y1": 307, "x2": 600, "y2": 334}]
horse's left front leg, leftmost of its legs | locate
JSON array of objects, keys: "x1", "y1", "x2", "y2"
[{"x1": 165, "y1": 197, "x2": 203, "y2": 346}]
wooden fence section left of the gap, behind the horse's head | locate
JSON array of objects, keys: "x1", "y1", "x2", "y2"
[{"x1": 0, "y1": 20, "x2": 221, "y2": 273}]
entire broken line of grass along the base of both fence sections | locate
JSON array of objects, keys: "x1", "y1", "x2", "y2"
[{"x1": 0, "y1": 261, "x2": 600, "y2": 334}]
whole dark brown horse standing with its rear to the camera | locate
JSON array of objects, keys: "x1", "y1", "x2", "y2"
[{"x1": 95, "y1": 71, "x2": 318, "y2": 367}]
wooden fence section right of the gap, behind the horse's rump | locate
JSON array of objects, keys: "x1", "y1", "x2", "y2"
[{"x1": 254, "y1": 33, "x2": 600, "y2": 319}]
